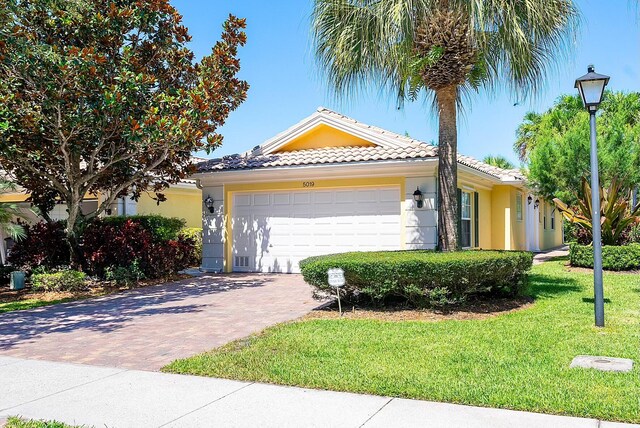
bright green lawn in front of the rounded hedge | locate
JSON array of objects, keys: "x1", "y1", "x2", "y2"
[{"x1": 163, "y1": 261, "x2": 640, "y2": 422}]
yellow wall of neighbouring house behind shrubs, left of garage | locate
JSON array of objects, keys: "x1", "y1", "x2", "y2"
[{"x1": 138, "y1": 187, "x2": 202, "y2": 227}]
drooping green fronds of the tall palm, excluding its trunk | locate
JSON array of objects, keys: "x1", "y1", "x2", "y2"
[{"x1": 312, "y1": 0, "x2": 580, "y2": 106}]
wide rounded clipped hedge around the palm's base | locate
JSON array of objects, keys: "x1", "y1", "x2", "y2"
[{"x1": 300, "y1": 251, "x2": 533, "y2": 306}]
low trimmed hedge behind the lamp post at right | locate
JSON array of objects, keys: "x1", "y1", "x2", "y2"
[{"x1": 569, "y1": 243, "x2": 640, "y2": 270}]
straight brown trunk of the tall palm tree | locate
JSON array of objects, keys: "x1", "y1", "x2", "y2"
[{"x1": 436, "y1": 86, "x2": 458, "y2": 251}]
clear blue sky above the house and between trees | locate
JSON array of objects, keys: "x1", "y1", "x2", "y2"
[{"x1": 171, "y1": 0, "x2": 640, "y2": 164}]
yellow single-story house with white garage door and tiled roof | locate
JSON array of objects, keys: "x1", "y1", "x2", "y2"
[{"x1": 192, "y1": 108, "x2": 563, "y2": 272}]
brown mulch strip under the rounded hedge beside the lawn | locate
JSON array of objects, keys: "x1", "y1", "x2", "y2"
[{"x1": 304, "y1": 297, "x2": 533, "y2": 321}]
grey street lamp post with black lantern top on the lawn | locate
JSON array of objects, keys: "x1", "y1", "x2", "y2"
[{"x1": 575, "y1": 65, "x2": 609, "y2": 327}]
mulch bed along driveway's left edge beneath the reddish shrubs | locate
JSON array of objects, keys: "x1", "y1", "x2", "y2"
[{"x1": 0, "y1": 275, "x2": 191, "y2": 303}]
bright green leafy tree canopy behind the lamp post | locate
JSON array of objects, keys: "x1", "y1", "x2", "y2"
[{"x1": 514, "y1": 92, "x2": 640, "y2": 205}]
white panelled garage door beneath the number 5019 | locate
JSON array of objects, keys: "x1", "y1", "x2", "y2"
[{"x1": 231, "y1": 187, "x2": 401, "y2": 272}]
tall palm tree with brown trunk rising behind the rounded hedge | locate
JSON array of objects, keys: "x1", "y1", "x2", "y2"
[{"x1": 312, "y1": 0, "x2": 578, "y2": 251}]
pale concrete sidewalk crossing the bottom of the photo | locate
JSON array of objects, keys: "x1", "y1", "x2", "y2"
[{"x1": 0, "y1": 356, "x2": 633, "y2": 428}]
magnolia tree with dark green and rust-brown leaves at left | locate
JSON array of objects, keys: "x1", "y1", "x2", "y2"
[{"x1": 0, "y1": 0, "x2": 248, "y2": 262}]
